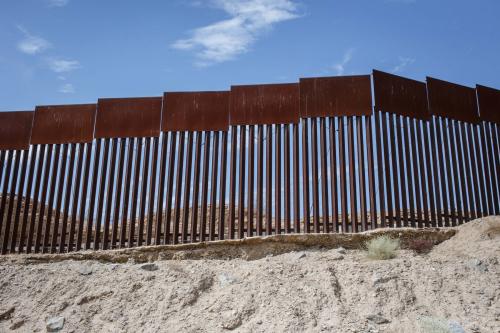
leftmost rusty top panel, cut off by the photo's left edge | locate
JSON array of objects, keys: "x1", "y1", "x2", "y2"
[{"x1": 0, "y1": 111, "x2": 34, "y2": 150}]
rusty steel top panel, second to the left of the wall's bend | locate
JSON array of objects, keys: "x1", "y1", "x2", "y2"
[{"x1": 229, "y1": 83, "x2": 300, "y2": 125}]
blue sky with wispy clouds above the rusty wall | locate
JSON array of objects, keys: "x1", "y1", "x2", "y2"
[{"x1": 0, "y1": 0, "x2": 500, "y2": 111}]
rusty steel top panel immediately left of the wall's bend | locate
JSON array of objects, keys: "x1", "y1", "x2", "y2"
[{"x1": 300, "y1": 75, "x2": 372, "y2": 117}]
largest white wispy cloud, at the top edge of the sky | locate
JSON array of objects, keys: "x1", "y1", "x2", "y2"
[{"x1": 172, "y1": 0, "x2": 299, "y2": 67}]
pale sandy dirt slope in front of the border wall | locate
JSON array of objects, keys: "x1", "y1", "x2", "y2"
[{"x1": 0, "y1": 217, "x2": 500, "y2": 333}]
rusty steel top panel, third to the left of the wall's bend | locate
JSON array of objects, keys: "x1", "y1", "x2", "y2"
[{"x1": 161, "y1": 91, "x2": 229, "y2": 131}]
